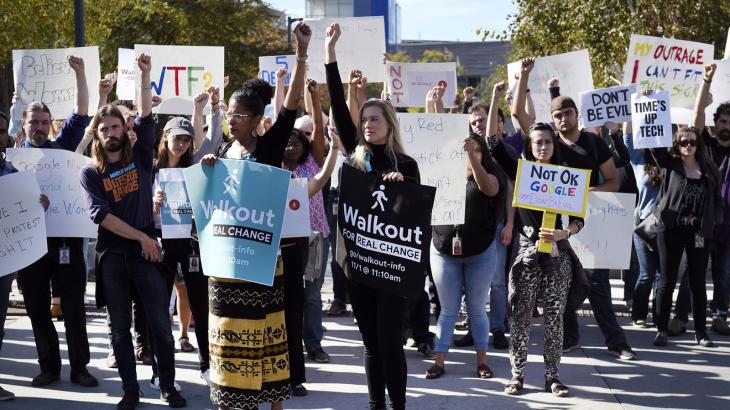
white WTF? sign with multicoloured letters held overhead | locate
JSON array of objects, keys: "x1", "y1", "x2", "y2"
[{"x1": 134, "y1": 44, "x2": 224, "y2": 115}]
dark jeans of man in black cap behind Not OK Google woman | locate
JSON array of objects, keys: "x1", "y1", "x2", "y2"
[{"x1": 563, "y1": 269, "x2": 626, "y2": 349}]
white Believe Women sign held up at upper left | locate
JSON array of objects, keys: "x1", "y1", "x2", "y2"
[{"x1": 13, "y1": 46, "x2": 101, "y2": 119}]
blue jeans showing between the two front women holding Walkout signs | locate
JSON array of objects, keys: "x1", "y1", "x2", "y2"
[{"x1": 302, "y1": 234, "x2": 332, "y2": 352}]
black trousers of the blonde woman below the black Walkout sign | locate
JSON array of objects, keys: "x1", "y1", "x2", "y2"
[{"x1": 347, "y1": 280, "x2": 408, "y2": 409}]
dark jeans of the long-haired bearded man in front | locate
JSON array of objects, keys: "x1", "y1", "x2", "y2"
[{"x1": 99, "y1": 246, "x2": 175, "y2": 392}]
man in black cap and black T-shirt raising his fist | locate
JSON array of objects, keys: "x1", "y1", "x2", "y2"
[{"x1": 512, "y1": 58, "x2": 636, "y2": 360}]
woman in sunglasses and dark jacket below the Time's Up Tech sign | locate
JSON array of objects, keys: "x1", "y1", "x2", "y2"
[{"x1": 652, "y1": 123, "x2": 722, "y2": 347}]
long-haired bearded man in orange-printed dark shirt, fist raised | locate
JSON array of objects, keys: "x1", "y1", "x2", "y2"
[{"x1": 81, "y1": 54, "x2": 187, "y2": 409}]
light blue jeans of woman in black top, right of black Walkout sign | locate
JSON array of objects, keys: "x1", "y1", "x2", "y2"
[{"x1": 431, "y1": 242, "x2": 496, "y2": 353}]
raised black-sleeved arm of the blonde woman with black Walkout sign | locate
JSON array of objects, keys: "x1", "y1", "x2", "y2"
[{"x1": 325, "y1": 23, "x2": 357, "y2": 154}]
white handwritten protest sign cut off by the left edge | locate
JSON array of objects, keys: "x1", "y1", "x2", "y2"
[{"x1": 0, "y1": 172, "x2": 48, "y2": 276}]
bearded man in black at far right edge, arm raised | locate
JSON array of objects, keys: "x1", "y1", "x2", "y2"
[{"x1": 692, "y1": 64, "x2": 730, "y2": 336}]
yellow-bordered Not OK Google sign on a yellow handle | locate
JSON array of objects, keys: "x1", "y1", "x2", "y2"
[{"x1": 512, "y1": 159, "x2": 591, "y2": 217}]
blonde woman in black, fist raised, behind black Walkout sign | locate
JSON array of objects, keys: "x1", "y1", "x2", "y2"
[{"x1": 325, "y1": 24, "x2": 416, "y2": 409}]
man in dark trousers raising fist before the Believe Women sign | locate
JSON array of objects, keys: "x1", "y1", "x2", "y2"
[{"x1": 18, "y1": 56, "x2": 99, "y2": 387}]
